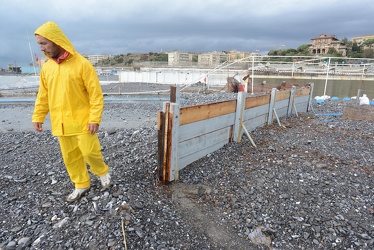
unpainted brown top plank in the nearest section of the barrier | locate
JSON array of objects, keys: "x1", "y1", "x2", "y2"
[{"x1": 180, "y1": 100, "x2": 236, "y2": 125}]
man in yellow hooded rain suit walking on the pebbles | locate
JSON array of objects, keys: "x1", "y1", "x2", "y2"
[{"x1": 32, "y1": 22, "x2": 111, "y2": 202}]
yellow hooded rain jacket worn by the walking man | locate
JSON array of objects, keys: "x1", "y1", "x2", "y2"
[{"x1": 32, "y1": 22, "x2": 104, "y2": 136}]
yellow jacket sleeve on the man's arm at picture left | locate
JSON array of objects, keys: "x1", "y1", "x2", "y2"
[{"x1": 32, "y1": 72, "x2": 49, "y2": 123}]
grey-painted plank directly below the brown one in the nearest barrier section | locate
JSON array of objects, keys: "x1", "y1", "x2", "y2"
[{"x1": 178, "y1": 113, "x2": 235, "y2": 142}]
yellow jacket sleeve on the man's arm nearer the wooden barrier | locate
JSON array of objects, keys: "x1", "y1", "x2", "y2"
[{"x1": 83, "y1": 61, "x2": 104, "y2": 125}]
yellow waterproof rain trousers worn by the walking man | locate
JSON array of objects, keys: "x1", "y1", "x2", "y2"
[{"x1": 58, "y1": 134, "x2": 108, "y2": 188}]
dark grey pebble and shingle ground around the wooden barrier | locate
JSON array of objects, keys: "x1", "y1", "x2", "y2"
[{"x1": 0, "y1": 86, "x2": 374, "y2": 249}]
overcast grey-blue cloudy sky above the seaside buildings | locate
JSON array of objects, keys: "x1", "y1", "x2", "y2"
[{"x1": 0, "y1": 0, "x2": 374, "y2": 68}]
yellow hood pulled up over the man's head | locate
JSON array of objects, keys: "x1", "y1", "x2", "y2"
[{"x1": 34, "y1": 22, "x2": 75, "y2": 57}]
